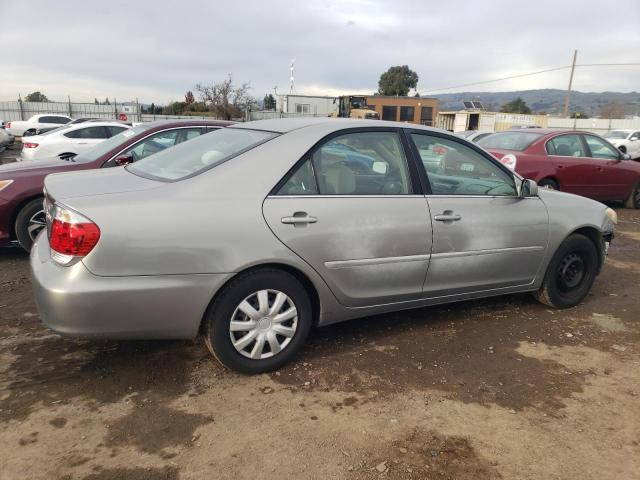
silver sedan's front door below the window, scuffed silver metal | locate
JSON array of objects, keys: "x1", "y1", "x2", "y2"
[{"x1": 424, "y1": 195, "x2": 548, "y2": 297}]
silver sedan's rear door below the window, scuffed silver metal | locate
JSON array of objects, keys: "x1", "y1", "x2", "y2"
[{"x1": 263, "y1": 195, "x2": 432, "y2": 307}]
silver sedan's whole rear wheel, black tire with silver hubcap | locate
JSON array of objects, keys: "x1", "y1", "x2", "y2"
[{"x1": 204, "y1": 269, "x2": 312, "y2": 373}]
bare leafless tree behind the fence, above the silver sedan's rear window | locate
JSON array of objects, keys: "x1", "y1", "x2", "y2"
[{"x1": 195, "y1": 74, "x2": 256, "y2": 120}]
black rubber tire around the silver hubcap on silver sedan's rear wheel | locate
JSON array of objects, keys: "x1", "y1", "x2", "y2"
[{"x1": 203, "y1": 268, "x2": 313, "y2": 374}]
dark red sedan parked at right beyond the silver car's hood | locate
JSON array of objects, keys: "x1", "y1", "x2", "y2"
[{"x1": 478, "y1": 129, "x2": 640, "y2": 208}]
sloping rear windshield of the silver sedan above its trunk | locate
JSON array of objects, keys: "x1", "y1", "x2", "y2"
[{"x1": 126, "y1": 128, "x2": 277, "y2": 182}]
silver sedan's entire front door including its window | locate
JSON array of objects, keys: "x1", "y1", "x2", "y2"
[{"x1": 410, "y1": 131, "x2": 549, "y2": 298}]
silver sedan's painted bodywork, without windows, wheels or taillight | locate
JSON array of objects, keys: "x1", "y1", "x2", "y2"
[{"x1": 31, "y1": 118, "x2": 608, "y2": 338}]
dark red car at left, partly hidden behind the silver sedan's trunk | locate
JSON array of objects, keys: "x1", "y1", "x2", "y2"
[{"x1": 0, "y1": 120, "x2": 233, "y2": 250}]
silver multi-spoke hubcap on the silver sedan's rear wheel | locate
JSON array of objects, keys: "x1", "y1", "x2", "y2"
[{"x1": 229, "y1": 289, "x2": 298, "y2": 360}]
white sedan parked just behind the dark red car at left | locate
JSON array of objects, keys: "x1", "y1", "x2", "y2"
[{"x1": 18, "y1": 122, "x2": 131, "y2": 161}]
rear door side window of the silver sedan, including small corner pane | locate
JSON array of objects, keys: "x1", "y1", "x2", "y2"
[{"x1": 278, "y1": 132, "x2": 411, "y2": 195}]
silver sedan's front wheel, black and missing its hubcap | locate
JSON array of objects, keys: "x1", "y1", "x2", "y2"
[{"x1": 534, "y1": 234, "x2": 600, "y2": 308}]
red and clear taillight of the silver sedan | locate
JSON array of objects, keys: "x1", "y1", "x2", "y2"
[{"x1": 45, "y1": 204, "x2": 100, "y2": 265}]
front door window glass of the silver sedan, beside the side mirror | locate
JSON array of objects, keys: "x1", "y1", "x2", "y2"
[{"x1": 411, "y1": 133, "x2": 517, "y2": 196}]
